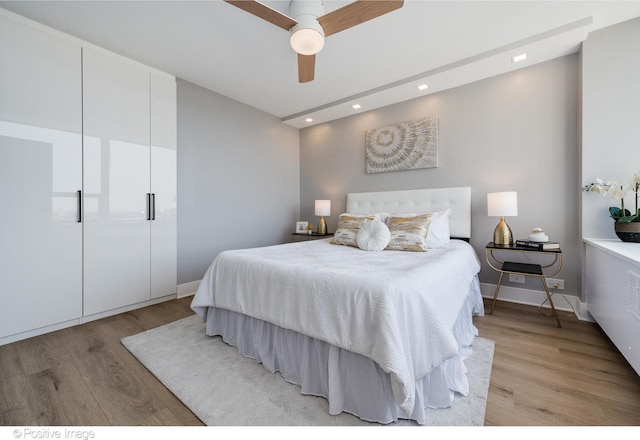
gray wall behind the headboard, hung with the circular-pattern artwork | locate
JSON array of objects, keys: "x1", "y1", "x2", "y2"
[{"x1": 300, "y1": 54, "x2": 581, "y2": 295}]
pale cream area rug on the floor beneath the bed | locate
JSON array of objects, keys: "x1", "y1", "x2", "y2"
[{"x1": 122, "y1": 315, "x2": 495, "y2": 426}]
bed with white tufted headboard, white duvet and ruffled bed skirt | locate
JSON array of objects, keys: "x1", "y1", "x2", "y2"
[{"x1": 191, "y1": 187, "x2": 484, "y2": 424}]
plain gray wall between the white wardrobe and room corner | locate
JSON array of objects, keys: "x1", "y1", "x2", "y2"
[{"x1": 178, "y1": 80, "x2": 300, "y2": 284}]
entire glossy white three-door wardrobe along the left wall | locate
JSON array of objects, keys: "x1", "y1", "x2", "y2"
[{"x1": 0, "y1": 10, "x2": 177, "y2": 344}]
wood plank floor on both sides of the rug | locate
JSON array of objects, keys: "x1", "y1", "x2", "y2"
[{"x1": 0, "y1": 297, "x2": 640, "y2": 426}]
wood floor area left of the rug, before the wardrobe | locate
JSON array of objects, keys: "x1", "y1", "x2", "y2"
[{"x1": 0, "y1": 298, "x2": 202, "y2": 426}]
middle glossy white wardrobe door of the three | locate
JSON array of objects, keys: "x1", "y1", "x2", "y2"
[{"x1": 82, "y1": 48, "x2": 151, "y2": 315}]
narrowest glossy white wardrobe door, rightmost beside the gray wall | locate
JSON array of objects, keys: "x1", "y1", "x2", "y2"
[{"x1": 151, "y1": 74, "x2": 178, "y2": 298}]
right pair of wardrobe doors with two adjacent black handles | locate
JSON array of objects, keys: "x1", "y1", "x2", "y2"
[{"x1": 83, "y1": 49, "x2": 177, "y2": 315}]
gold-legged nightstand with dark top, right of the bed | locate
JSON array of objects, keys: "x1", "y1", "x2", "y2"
[{"x1": 485, "y1": 242, "x2": 562, "y2": 327}]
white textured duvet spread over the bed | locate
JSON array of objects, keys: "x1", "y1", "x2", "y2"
[{"x1": 191, "y1": 239, "x2": 480, "y2": 415}]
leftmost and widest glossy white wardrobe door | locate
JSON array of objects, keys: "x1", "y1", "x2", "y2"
[{"x1": 0, "y1": 16, "x2": 82, "y2": 337}]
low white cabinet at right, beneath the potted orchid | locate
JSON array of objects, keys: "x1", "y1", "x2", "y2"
[{"x1": 585, "y1": 239, "x2": 640, "y2": 374}]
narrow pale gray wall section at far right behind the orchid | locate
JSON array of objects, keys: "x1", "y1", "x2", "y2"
[{"x1": 581, "y1": 18, "x2": 640, "y2": 239}]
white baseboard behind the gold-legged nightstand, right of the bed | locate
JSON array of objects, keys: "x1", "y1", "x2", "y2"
[{"x1": 480, "y1": 283, "x2": 595, "y2": 322}]
